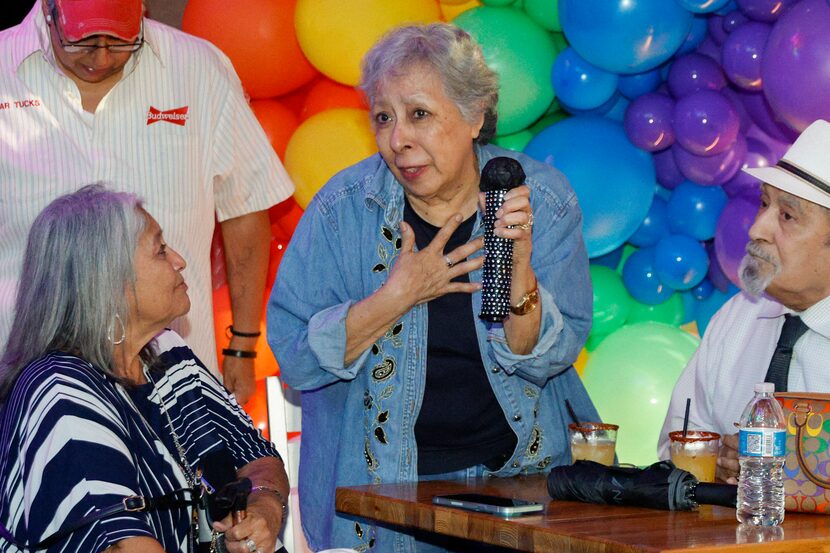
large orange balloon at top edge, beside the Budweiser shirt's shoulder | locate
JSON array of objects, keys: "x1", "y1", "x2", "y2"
[{"x1": 182, "y1": 0, "x2": 317, "y2": 98}]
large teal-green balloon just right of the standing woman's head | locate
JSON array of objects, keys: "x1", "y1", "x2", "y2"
[{"x1": 453, "y1": 6, "x2": 556, "y2": 134}]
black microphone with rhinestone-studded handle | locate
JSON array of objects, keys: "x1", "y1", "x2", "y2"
[{"x1": 479, "y1": 156, "x2": 525, "y2": 323}]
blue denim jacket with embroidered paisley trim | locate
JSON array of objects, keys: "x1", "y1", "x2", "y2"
[{"x1": 267, "y1": 146, "x2": 598, "y2": 553}]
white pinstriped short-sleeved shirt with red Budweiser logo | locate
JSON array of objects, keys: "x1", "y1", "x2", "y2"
[{"x1": 0, "y1": 2, "x2": 293, "y2": 370}]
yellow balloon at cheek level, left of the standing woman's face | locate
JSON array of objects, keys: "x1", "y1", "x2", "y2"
[{"x1": 285, "y1": 108, "x2": 377, "y2": 209}]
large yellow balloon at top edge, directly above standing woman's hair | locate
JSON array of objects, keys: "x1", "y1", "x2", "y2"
[{"x1": 294, "y1": 0, "x2": 441, "y2": 86}]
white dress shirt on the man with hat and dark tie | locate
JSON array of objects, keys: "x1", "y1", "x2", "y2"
[{"x1": 658, "y1": 292, "x2": 830, "y2": 459}]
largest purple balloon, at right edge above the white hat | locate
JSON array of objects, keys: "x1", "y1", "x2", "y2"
[{"x1": 759, "y1": 0, "x2": 830, "y2": 132}]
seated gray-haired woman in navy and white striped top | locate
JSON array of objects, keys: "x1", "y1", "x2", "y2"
[{"x1": 0, "y1": 185, "x2": 288, "y2": 553}]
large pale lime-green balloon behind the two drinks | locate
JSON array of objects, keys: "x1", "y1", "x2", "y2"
[{"x1": 582, "y1": 322, "x2": 700, "y2": 465}]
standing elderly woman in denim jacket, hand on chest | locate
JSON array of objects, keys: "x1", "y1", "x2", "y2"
[{"x1": 268, "y1": 23, "x2": 597, "y2": 552}]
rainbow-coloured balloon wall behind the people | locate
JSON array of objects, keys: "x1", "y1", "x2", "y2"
[{"x1": 182, "y1": 0, "x2": 830, "y2": 464}]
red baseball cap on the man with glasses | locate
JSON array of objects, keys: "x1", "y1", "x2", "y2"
[{"x1": 56, "y1": 0, "x2": 144, "y2": 42}]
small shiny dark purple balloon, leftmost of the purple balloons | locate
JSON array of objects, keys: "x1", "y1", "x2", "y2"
[{"x1": 625, "y1": 92, "x2": 674, "y2": 152}]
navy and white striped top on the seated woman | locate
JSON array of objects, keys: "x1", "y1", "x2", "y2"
[{"x1": 0, "y1": 331, "x2": 277, "y2": 552}]
